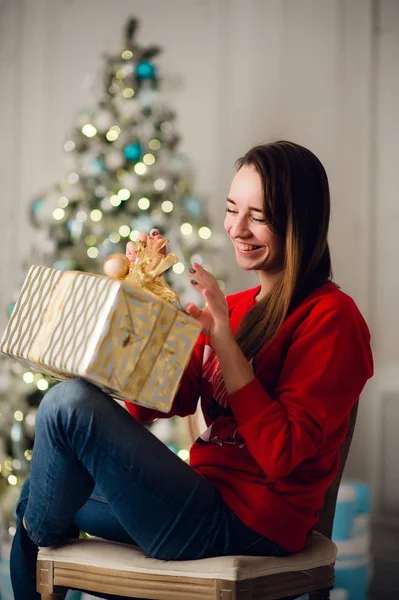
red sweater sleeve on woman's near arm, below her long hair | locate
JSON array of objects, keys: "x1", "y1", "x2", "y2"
[{"x1": 228, "y1": 299, "x2": 373, "y2": 480}]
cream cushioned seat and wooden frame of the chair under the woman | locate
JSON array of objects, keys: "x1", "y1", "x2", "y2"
[{"x1": 37, "y1": 533, "x2": 337, "y2": 600}]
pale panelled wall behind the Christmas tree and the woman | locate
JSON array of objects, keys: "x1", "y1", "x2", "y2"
[{"x1": 0, "y1": 0, "x2": 399, "y2": 516}]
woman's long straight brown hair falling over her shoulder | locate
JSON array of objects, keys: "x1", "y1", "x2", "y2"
[{"x1": 236, "y1": 141, "x2": 332, "y2": 359}]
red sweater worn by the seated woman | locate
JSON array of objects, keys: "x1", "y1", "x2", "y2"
[{"x1": 127, "y1": 283, "x2": 373, "y2": 552}]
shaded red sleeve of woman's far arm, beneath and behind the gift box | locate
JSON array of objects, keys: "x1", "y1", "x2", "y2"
[{"x1": 125, "y1": 334, "x2": 204, "y2": 423}]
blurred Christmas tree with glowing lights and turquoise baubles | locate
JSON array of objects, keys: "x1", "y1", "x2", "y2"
[{"x1": 0, "y1": 19, "x2": 224, "y2": 533}]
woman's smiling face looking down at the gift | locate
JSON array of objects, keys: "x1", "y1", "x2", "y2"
[{"x1": 224, "y1": 165, "x2": 284, "y2": 274}]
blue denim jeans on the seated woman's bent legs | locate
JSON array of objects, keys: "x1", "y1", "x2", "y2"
[{"x1": 10, "y1": 379, "x2": 288, "y2": 600}]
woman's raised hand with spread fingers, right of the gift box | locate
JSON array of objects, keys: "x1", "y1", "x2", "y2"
[{"x1": 186, "y1": 263, "x2": 235, "y2": 352}]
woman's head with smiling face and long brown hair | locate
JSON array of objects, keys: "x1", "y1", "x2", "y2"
[{"x1": 225, "y1": 141, "x2": 332, "y2": 356}]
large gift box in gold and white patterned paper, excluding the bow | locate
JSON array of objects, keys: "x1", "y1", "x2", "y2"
[{"x1": 0, "y1": 266, "x2": 201, "y2": 412}]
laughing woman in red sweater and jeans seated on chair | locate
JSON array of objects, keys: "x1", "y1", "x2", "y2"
[{"x1": 11, "y1": 141, "x2": 373, "y2": 600}]
